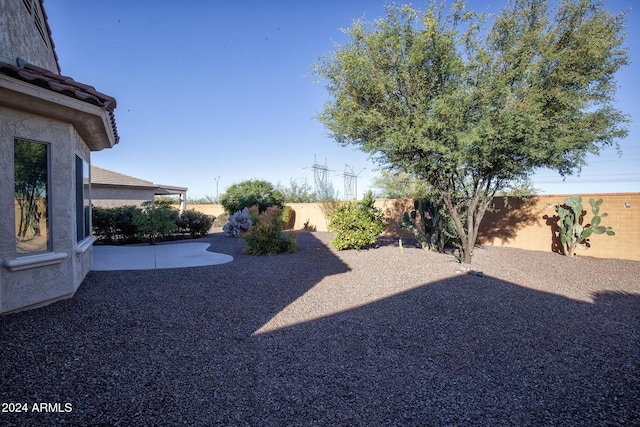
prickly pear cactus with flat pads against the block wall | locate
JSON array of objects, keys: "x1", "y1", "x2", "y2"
[{"x1": 555, "y1": 195, "x2": 616, "y2": 256}]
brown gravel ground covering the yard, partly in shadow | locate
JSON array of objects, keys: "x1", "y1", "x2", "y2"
[{"x1": 0, "y1": 233, "x2": 640, "y2": 426}]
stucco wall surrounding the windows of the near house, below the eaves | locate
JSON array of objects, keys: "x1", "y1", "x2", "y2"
[{"x1": 0, "y1": 107, "x2": 92, "y2": 312}]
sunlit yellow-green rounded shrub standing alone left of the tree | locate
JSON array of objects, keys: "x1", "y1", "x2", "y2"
[{"x1": 329, "y1": 191, "x2": 385, "y2": 250}]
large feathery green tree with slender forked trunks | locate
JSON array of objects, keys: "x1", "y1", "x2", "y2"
[{"x1": 314, "y1": 0, "x2": 628, "y2": 263}]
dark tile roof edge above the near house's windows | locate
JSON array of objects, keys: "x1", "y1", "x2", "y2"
[{"x1": 0, "y1": 60, "x2": 120, "y2": 143}]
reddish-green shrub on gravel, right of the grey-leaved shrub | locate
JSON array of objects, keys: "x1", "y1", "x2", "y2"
[{"x1": 242, "y1": 206, "x2": 297, "y2": 255}]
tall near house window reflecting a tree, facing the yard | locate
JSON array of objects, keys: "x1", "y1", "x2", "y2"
[{"x1": 13, "y1": 139, "x2": 51, "y2": 254}]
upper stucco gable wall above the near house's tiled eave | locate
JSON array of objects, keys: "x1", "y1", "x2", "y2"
[{"x1": 0, "y1": 0, "x2": 58, "y2": 74}]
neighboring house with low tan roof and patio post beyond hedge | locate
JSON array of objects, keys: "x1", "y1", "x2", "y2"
[{"x1": 91, "y1": 165, "x2": 188, "y2": 212}]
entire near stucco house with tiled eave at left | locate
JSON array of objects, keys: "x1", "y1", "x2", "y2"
[{"x1": 0, "y1": 0, "x2": 119, "y2": 313}]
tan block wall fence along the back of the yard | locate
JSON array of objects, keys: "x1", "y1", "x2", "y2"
[{"x1": 188, "y1": 192, "x2": 640, "y2": 261}]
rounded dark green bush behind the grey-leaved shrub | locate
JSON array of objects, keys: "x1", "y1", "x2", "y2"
[{"x1": 220, "y1": 179, "x2": 284, "y2": 214}]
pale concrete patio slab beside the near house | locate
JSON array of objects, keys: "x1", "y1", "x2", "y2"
[{"x1": 92, "y1": 243, "x2": 233, "y2": 271}]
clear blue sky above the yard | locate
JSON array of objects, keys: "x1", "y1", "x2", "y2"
[{"x1": 45, "y1": 0, "x2": 640, "y2": 198}]
